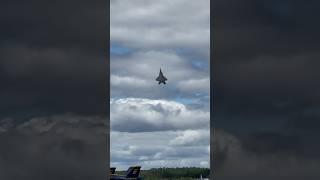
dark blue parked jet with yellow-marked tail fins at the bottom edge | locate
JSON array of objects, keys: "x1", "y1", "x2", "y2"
[{"x1": 110, "y1": 166, "x2": 142, "y2": 180}]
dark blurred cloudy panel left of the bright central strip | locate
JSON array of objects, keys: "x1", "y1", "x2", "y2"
[{"x1": 0, "y1": 0, "x2": 109, "y2": 180}]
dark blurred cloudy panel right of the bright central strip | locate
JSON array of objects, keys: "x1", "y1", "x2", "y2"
[{"x1": 211, "y1": 0, "x2": 320, "y2": 179}]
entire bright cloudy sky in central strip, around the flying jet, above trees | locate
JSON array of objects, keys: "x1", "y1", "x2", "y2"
[{"x1": 110, "y1": 0, "x2": 210, "y2": 169}]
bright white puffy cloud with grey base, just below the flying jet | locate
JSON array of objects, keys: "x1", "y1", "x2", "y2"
[{"x1": 110, "y1": 98, "x2": 210, "y2": 132}]
